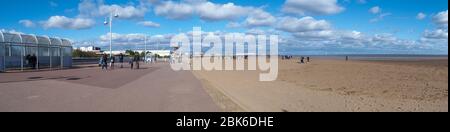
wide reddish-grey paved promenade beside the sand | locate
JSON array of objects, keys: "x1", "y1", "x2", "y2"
[{"x1": 0, "y1": 64, "x2": 221, "y2": 112}]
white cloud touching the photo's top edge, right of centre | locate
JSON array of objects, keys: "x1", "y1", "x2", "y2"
[{"x1": 282, "y1": 0, "x2": 345, "y2": 15}]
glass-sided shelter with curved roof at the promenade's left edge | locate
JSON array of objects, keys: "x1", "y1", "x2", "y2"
[{"x1": 0, "y1": 32, "x2": 72, "y2": 72}]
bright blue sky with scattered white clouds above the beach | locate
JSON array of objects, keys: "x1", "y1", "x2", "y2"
[{"x1": 0, "y1": 0, "x2": 448, "y2": 54}]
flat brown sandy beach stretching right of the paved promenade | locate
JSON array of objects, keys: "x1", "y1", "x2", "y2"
[{"x1": 193, "y1": 57, "x2": 448, "y2": 112}]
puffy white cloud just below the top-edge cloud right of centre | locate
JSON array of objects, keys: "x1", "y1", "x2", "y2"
[{"x1": 276, "y1": 16, "x2": 331, "y2": 33}]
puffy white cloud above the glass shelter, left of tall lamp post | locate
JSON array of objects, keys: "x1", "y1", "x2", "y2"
[{"x1": 41, "y1": 16, "x2": 95, "y2": 30}]
